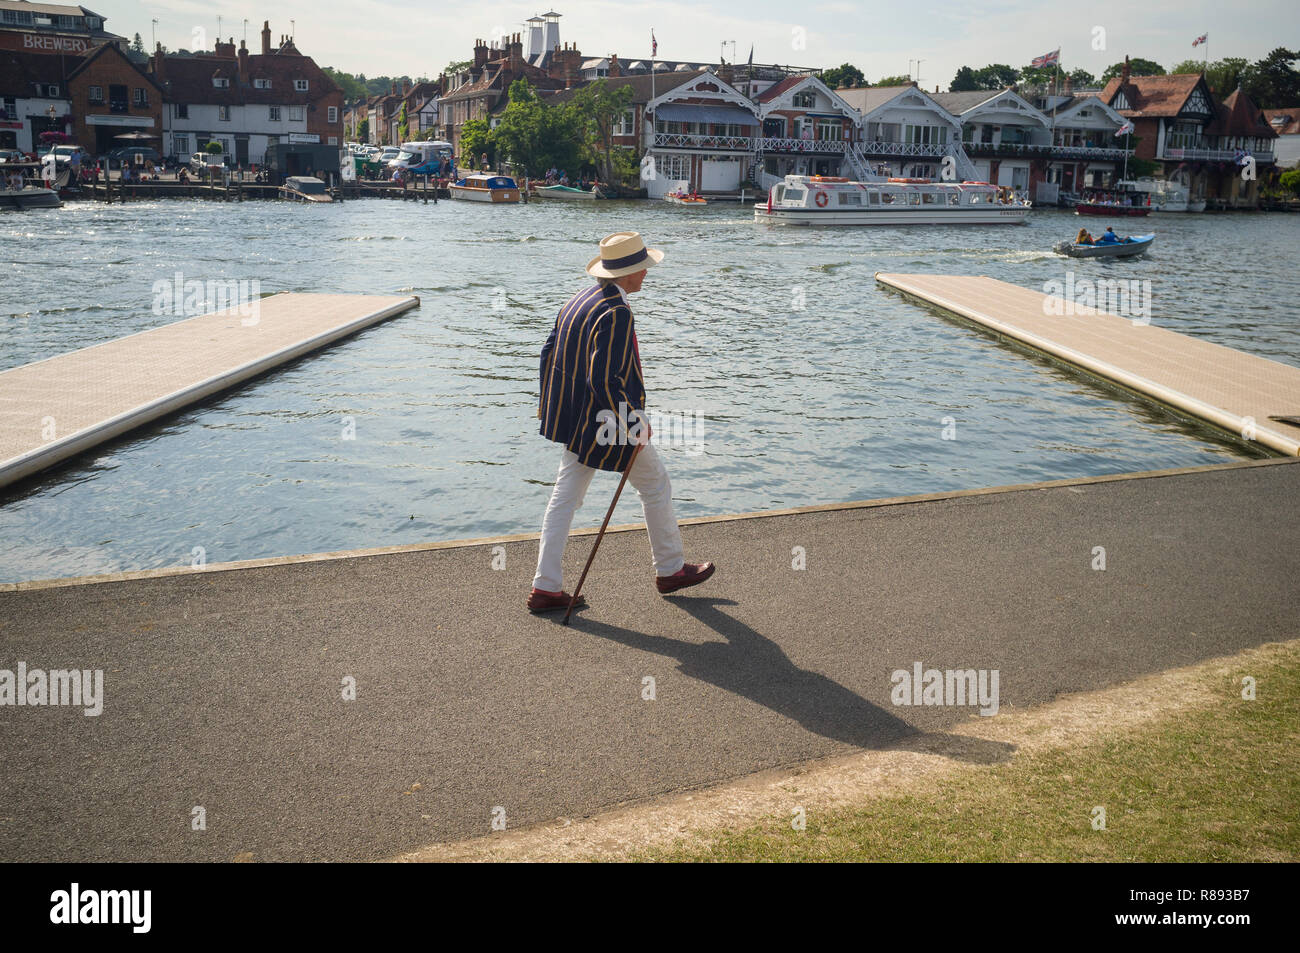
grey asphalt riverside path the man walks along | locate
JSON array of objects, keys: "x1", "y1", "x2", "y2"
[{"x1": 0, "y1": 463, "x2": 1300, "y2": 861}]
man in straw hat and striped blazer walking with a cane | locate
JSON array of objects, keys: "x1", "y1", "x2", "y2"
[{"x1": 528, "y1": 231, "x2": 714, "y2": 612}]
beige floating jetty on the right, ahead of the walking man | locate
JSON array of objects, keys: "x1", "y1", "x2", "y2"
[{"x1": 876, "y1": 272, "x2": 1300, "y2": 456}]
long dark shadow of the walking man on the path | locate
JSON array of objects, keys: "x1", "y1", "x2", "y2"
[{"x1": 575, "y1": 595, "x2": 1015, "y2": 764}]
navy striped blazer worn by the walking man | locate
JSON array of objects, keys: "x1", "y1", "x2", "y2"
[{"x1": 537, "y1": 285, "x2": 646, "y2": 472}]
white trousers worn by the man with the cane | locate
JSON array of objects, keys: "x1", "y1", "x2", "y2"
[{"x1": 533, "y1": 443, "x2": 685, "y2": 593}]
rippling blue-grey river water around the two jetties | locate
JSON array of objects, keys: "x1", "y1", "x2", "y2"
[{"x1": 0, "y1": 200, "x2": 1300, "y2": 581}]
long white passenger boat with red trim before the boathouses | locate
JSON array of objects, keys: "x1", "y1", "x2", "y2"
[{"x1": 754, "y1": 176, "x2": 1031, "y2": 225}]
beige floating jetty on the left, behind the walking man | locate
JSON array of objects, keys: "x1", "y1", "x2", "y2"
[{"x1": 0, "y1": 294, "x2": 420, "y2": 486}]
